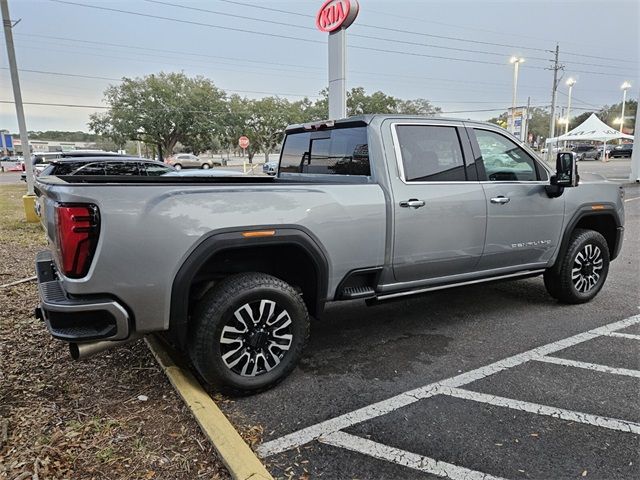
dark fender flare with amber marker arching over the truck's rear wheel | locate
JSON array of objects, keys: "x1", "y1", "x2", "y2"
[{"x1": 169, "y1": 225, "x2": 329, "y2": 347}]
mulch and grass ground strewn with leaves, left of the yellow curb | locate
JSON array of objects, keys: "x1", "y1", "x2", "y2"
[{"x1": 0, "y1": 185, "x2": 235, "y2": 480}]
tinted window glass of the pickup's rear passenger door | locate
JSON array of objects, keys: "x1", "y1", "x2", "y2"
[{"x1": 396, "y1": 125, "x2": 466, "y2": 182}]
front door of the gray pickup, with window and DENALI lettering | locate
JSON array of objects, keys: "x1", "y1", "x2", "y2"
[{"x1": 469, "y1": 126, "x2": 564, "y2": 270}]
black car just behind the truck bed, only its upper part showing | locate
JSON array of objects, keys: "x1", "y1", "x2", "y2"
[{"x1": 40, "y1": 156, "x2": 175, "y2": 177}]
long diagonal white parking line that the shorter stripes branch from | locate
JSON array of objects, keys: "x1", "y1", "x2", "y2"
[{"x1": 256, "y1": 315, "x2": 640, "y2": 458}]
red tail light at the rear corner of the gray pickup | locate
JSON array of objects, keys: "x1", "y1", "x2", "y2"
[{"x1": 56, "y1": 204, "x2": 100, "y2": 278}]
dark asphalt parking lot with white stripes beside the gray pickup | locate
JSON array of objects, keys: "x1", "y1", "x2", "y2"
[{"x1": 216, "y1": 182, "x2": 640, "y2": 479}]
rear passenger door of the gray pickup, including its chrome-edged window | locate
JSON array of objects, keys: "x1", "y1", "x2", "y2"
[{"x1": 388, "y1": 120, "x2": 486, "y2": 283}]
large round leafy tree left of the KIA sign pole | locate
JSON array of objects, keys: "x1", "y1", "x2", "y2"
[{"x1": 89, "y1": 72, "x2": 226, "y2": 155}]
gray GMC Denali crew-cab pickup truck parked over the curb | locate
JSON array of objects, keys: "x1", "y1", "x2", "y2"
[{"x1": 36, "y1": 115, "x2": 624, "y2": 392}]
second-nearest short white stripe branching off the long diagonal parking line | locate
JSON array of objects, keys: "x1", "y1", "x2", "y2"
[{"x1": 441, "y1": 387, "x2": 640, "y2": 435}]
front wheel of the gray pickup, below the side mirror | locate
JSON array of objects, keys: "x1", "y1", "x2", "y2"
[{"x1": 544, "y1": 228, "x2": 609, "y2": 304}]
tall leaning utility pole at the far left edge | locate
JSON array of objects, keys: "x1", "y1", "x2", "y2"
[{"x1": 0, "y1": 0, "x2": 38, "y2": 201}]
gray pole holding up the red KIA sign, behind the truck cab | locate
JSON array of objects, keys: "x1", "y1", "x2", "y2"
[{"x1": 329, "y1": 28, "x2": 347, "y2": 119}]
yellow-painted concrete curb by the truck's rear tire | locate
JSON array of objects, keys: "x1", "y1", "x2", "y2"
[{"x1": 145, "y1": 335, "x2": 273, "y2": 480}]
